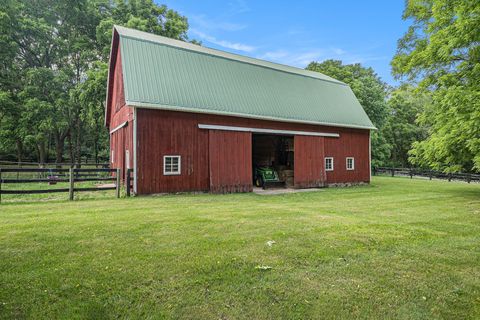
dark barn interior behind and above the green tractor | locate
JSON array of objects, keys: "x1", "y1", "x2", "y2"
[{"x1": 252, "y1": 134, "x2": 294, "y2": 187}]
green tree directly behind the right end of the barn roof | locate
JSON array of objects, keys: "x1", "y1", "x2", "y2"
[{"x1": 306, "y1": 60, "x2": 391, "y2": 166}]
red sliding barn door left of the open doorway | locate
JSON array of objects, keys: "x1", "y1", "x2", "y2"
[{"x1": 208, "y1": 130, "x2": 252, "y2": 193}]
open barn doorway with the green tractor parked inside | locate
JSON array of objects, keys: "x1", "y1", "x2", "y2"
[{"x1": 252, "y1": 134, "x2": 294, "y2": 189}]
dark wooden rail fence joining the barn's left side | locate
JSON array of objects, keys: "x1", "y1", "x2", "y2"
[{"x1": 0, "y1": 168, "x2": 133, "y2": 202}]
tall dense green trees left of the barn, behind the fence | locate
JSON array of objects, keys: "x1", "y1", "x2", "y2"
[{"x1": 0, "y1": 0, "x2": 188, "y2": 162}]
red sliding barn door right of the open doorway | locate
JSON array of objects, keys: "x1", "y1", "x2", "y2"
[{"x1": 294, "y1": 136, "x2": 326, "y2": 188}]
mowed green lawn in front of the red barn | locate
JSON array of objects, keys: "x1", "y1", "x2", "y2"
[{"x1": 0, "y1": 177, "x2": 480, "y2": 319}]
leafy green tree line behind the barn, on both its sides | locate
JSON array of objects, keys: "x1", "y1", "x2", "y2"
[{"x1": 0, "y1": 0, "x2": 480, "y2": 172}]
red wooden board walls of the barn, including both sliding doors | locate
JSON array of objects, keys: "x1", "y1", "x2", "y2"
[{"x1": 106, "y1": 31, "x2": 370, "y2": 194}]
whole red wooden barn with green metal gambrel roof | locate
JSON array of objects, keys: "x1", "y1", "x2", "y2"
[{"x1": 105, "y1": 26, "x2": 374, "y2": 194}]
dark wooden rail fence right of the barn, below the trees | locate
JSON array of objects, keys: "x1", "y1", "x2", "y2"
[{"x1": 372, "y1": 167, "x2": 480, "y2": 183}]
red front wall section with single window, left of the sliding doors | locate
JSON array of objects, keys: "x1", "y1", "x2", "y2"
[{"x1": 137, "y1": 109, "x2": 209, "y2": 194}]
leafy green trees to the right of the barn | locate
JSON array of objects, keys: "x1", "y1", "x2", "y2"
[{"x1": 307, "y1": 0, "x2": 480, "y2": 172}]
